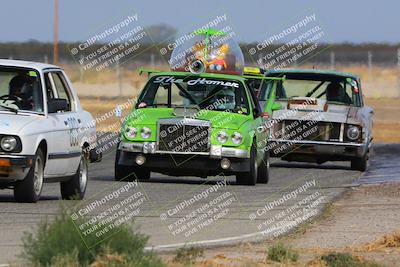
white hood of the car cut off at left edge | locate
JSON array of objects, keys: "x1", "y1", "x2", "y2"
[{"x1": 0, "y1": 113, "x2": 39, "y2": 135}]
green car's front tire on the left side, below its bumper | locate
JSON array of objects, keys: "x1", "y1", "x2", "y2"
[{"x1": 114, "y1": 150, "x2": 150, "y2": 182}]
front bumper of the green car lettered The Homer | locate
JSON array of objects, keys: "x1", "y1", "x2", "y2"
[{"x1": 118, "y1": 142, "x2": 250, "y2": 177}]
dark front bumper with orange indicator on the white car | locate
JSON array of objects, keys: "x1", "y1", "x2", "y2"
[{"x1": 0, "y1": 155, "x2": 35, "y2": 183}]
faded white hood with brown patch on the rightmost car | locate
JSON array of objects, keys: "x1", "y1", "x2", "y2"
[{"x1": 273, "y1": 97, "x2": 358, "y2": 123}]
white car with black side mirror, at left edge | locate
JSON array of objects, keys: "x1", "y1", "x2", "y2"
[{"x1": 0, "y1": 60, "x2": 101, "y2": 202}]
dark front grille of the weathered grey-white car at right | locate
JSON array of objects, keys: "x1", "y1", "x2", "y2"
[{"x1": 273, "y1": 120, "x2": 341, "y2": 141}]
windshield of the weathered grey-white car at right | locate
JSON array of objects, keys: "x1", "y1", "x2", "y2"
[{"x1": 260, "y1": 76, "x2": 360, "y2": 106}]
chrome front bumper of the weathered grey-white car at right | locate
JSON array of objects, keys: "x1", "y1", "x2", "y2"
[{"x1": 267, "y1": 139, "x2": 369, "y2": 160}]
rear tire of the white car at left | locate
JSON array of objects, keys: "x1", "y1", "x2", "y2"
[{"x1": 60, "y1": 154, "x2": 89, "y2": 200}]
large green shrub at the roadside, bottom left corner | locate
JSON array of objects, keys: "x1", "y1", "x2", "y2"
[{"x1": 21, "y1": 206, "x2": 162, "y2": 266}]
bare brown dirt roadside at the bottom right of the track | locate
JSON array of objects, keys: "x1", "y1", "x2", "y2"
[{"x1": 164, "y1": 183, "x2": 400, "y2": 267}]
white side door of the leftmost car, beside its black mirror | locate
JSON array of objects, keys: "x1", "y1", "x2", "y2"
[{"x1": 45, "y1": 71, "x2": 80, "y2": 176}]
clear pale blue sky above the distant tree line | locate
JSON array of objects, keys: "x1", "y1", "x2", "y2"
[{"x1": 0, "y1": 0, "x2": 400, "y2": 43}]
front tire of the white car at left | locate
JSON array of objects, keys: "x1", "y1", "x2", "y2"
[{"x1": 14, "y1": 149, "x2": 45, "y2": 203}]
